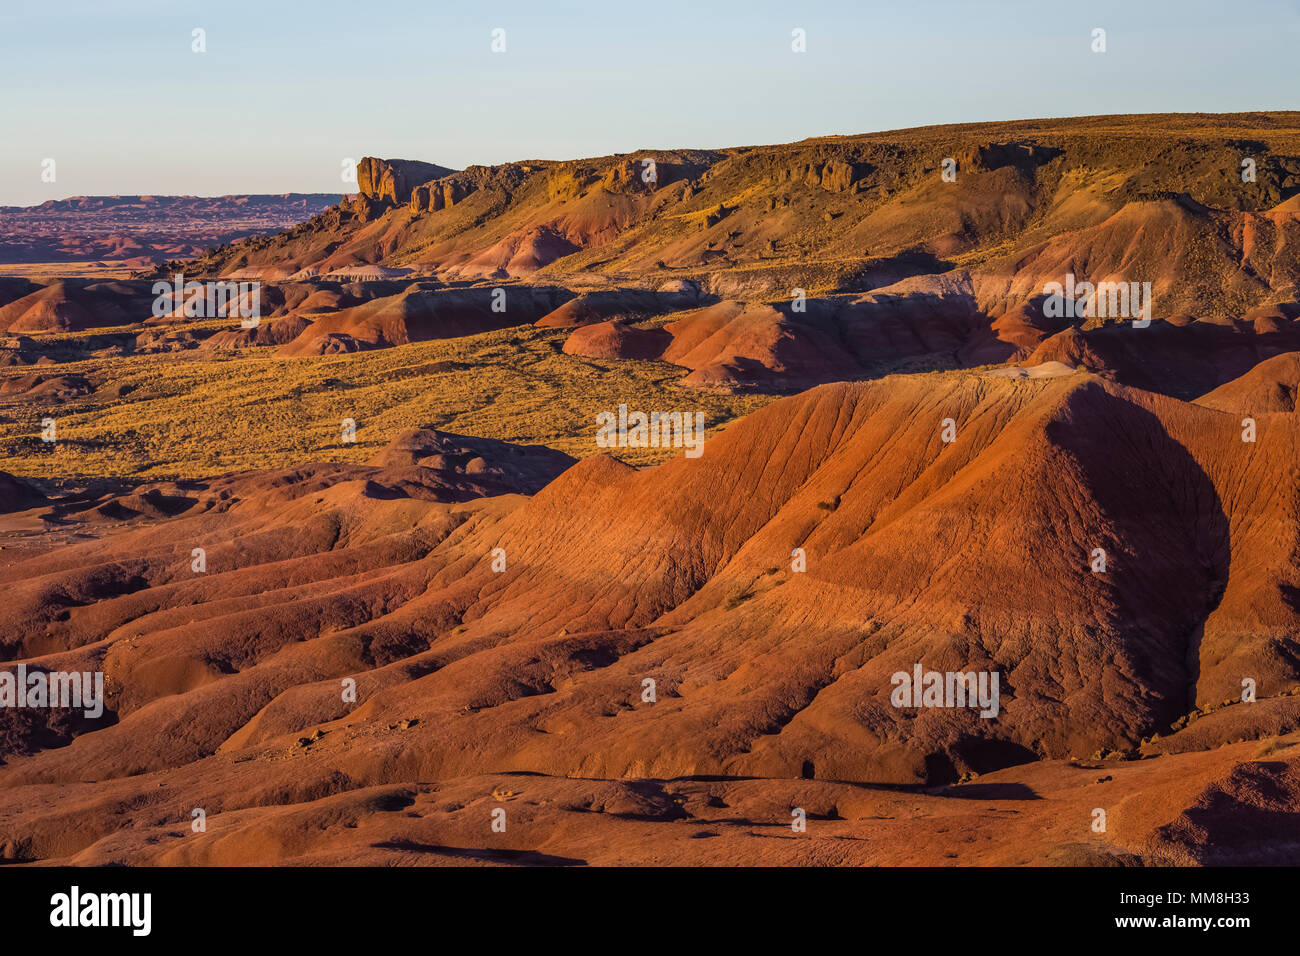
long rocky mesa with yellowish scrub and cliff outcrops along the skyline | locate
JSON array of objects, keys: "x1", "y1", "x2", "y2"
[{"x1": 183, "y1": 113, "x2": 1300, "y2": 310}]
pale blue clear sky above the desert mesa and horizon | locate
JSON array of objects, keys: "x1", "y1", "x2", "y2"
[{"x1": 0, "y1": 0, "x2": 1300, "y2": 206}]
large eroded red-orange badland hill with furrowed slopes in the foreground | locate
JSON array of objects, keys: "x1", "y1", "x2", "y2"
[{"x1": 0, "y1": 364, "x2": 1300, "y2": 861}]
